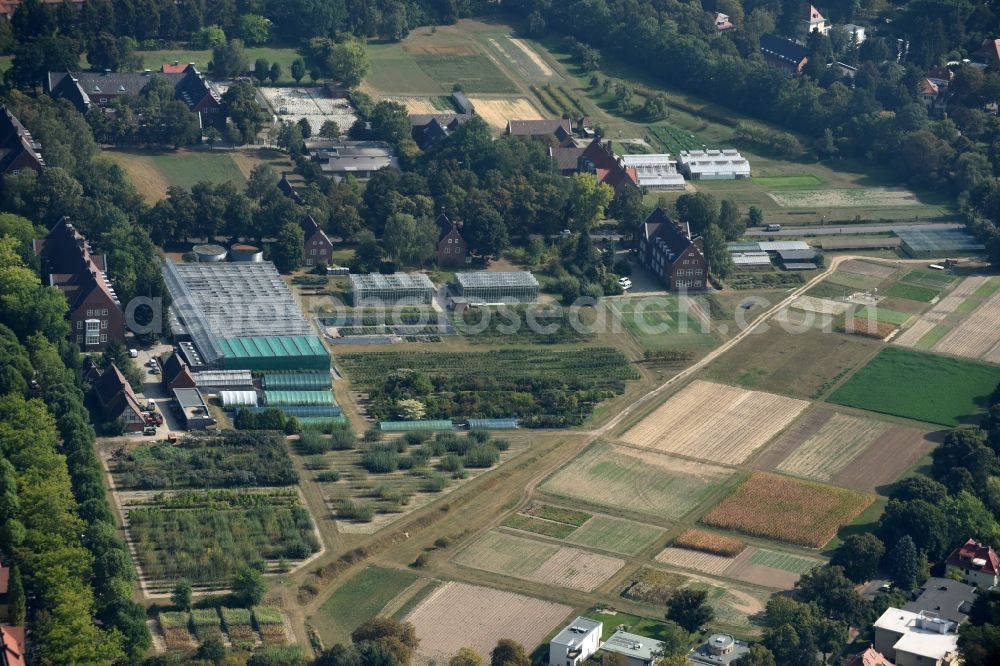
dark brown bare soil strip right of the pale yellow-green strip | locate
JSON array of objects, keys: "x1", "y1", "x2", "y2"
[{"x1": 831, "y1": 427, "x2": 934, "y2": 491}]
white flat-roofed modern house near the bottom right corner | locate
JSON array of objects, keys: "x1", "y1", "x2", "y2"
[{"x1": 875, "y1": 608, "x2": 960, "y2": 666}]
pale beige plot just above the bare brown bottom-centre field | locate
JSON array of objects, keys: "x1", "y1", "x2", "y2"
[{"x1": 452, "y1": 532, "x2": 625, "y2": 592}]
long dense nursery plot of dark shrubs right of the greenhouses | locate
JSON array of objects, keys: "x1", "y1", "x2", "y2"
[{"x1": 340, "y1": 347, "x2": 639, "y2": 427}]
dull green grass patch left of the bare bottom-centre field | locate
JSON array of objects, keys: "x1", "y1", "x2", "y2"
[{"x1": 312, "y1": 567, "x2": 418, "y2": 645}]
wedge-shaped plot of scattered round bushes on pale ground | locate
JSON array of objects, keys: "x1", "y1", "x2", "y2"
[{"x1": 326, "y1": 433, "x2": 530, "y2": 534}]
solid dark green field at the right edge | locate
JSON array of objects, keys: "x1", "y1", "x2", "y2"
[{"x1": 828, "y1": 347, "x2": 1000, "y2": 426}]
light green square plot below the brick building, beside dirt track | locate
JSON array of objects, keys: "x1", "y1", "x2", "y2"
[{"x1": 606, "y1": 294, "x2": 717, "y2": 350}]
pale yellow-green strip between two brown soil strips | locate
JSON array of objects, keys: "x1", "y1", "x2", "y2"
[{"x1": 778, "y1": 414, "x2": 890, "y2": 481}]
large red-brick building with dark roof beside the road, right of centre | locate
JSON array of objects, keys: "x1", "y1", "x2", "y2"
[{"x1": 636, "y1": 208, "x2": 710, "y2": 291}]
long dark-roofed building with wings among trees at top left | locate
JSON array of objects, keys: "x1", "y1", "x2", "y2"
[{"x1": 46, "y1": 64, "x2": 226, "y2": 129}]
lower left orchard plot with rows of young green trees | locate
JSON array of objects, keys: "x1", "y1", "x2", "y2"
[{"x1": 122, "y1": 489, "x2": 320, "y2": 588}]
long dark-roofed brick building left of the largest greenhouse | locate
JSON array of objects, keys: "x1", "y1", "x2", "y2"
[{"x1": 32, "y1": 217, "x2": 125, "y2": 352}]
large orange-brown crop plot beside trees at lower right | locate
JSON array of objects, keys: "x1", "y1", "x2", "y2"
[{"x1": 702, "y1": 472, "x2": 875, "y2": 548}]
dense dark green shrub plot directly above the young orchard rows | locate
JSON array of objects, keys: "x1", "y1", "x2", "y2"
[{"x1": 108, "y1": 432, "x2": 298, "y2": 490}]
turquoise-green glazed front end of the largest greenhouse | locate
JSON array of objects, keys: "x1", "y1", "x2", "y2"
[{"x1": 219, "y1": 335, "x2": 330, "y2": 371}]
